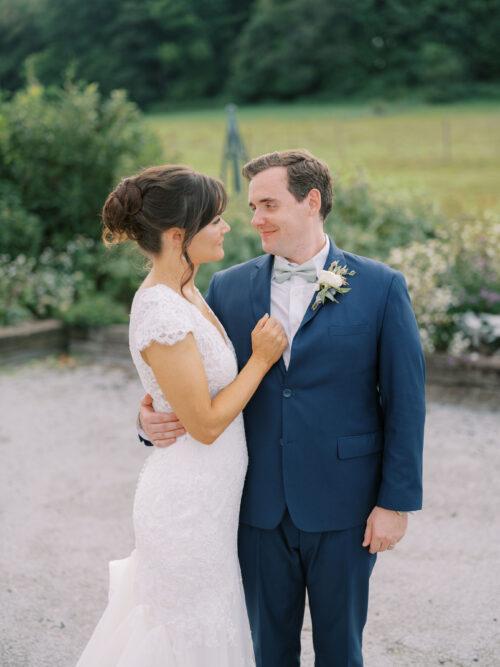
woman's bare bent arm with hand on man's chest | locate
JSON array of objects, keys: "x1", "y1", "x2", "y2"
[{"x1": 142, "y1": 316, "x2": 287, "y2": 445}]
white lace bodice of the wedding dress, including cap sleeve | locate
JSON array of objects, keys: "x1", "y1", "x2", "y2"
[{"x1": 129, "y1": 284, "x2": 238, "y2": 412}]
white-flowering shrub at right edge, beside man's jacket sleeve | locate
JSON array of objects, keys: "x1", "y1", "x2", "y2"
[{"x1": 389, "y1": 214, "x2": 500, "y2": 353}]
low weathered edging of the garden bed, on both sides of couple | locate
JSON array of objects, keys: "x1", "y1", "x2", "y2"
[{"x1": 0, "y1": 320, "x2": 500, "y2": 389}]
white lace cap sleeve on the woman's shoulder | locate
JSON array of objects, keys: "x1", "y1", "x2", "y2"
[{"x1": 134, "y1": 286, "x2": 194, "y2": 351}]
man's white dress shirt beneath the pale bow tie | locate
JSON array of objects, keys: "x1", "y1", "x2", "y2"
[{"x1": 270, "y1": 236, "x2": 330, "y2": 368}]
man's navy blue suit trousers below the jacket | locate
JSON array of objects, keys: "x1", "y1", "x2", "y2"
[{"x1": 238, "y1": 511, "x2": 376, "y2": 667}]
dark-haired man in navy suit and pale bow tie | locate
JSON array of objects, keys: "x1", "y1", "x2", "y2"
[{"x1": 141, "y1": 150, "x2": 425, "y2": 667}]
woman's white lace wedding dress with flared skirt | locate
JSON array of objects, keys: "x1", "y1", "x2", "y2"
[{"x1": 77, "y1": 285, "x2": 255, "y2": 667}]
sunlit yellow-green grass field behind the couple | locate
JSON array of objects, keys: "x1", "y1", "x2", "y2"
[{"x1": 147, "y1": 103, "x2": 500, "y2": 215}]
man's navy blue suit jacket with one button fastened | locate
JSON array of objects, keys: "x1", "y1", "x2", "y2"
[{"x1": 207, "y1": 241, "x2": 425, "y2": 531}]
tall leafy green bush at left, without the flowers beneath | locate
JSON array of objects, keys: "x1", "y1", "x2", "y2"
[{"x1": 0, "y1": 83, "x2": 160, "y2": 248}]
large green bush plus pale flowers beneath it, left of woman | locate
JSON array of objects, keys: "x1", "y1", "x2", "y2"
[{"x1": 0, "y1": 82, "x2": 158, "y2": 326}]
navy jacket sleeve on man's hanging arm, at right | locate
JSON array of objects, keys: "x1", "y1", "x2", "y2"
[{"x1": 377, "y1": 272, "x2": 425, "y2": 511}]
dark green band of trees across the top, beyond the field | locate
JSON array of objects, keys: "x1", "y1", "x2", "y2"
[{"x1": 0, "y1": 0, "x2": 500, "y2": 106}]
